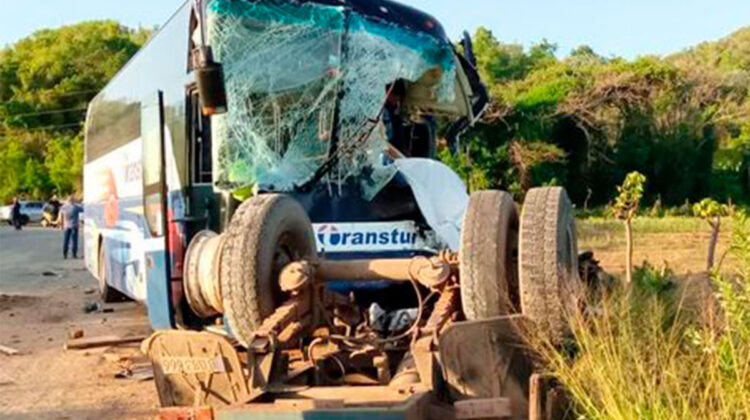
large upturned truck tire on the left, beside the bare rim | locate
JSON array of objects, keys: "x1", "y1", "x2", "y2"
[{"x1": 221, "y1": 194, "x2": 317, "y2": 346}]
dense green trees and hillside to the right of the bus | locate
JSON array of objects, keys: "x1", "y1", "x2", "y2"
[{"x1": 443, "y1": 27, "x2": 750, "y2": 206}]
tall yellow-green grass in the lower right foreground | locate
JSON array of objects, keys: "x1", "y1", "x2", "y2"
[{"x1": 537, "y1": 213, "x2": 750, "y2": 420}]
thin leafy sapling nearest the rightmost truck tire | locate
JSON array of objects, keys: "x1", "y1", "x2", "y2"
[{"x1": 612, "y1": 172, "x2": 646, "y2": 284}]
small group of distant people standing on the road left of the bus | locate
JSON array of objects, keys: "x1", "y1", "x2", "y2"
[{"x1": 11, "y1": 195, "x2": 83, "y2": 259}]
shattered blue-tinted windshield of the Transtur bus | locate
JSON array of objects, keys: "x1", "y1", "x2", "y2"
[{"x1": 208, "y1": 0, "x2": 456, "y2": 197}]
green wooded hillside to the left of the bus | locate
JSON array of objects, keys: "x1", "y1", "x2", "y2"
[{"x1": 0, "y1": 21, "x2": 151, "y2": 202}]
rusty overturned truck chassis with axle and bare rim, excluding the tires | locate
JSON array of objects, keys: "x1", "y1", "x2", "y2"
[{"x1": 144, "y1": 244, "x2": 560, "y2": 419}]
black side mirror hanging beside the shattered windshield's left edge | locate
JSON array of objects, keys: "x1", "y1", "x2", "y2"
[{"x1": 194, "y1": 47, "x2": 227, "y2": 115}]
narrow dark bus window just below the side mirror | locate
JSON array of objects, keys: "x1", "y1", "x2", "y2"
[{"x1": 190, "y1": 90, "x2": 213, "y2": 184}]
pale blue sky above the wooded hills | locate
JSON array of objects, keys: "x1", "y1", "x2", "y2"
[{"x1": 0, "y1": 0, "x2": 750, "y2": 58}]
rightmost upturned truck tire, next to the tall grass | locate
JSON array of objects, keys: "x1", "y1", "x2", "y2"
[{"x1": 519, "y1": 187, "x2": 582, "y2": 344}]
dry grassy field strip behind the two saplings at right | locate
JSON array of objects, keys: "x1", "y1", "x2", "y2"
[{"x1": 578, "y1": 216, "x2": 739, "y2": 275}]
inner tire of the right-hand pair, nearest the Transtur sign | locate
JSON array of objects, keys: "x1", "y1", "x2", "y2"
[{"x1": 458, "y1": 191, "x2": 518, "y2": 320}]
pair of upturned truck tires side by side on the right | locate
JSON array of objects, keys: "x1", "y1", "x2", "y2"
[{"x1": 459, "y1": 187, "x2": 580, "y2": 342}]
